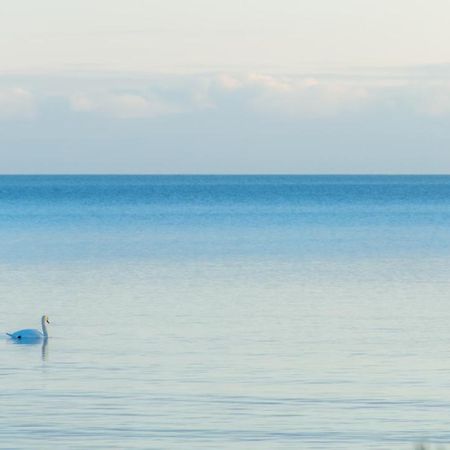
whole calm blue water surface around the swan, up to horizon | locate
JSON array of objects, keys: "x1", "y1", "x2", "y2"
[{"x1": 0, "y1": 176, "x2": 450, "y2": 450}]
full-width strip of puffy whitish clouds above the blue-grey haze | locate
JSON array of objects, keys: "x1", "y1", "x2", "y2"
[{"x1": 4, "y1": 70, "x2": 450, "y2": 121}]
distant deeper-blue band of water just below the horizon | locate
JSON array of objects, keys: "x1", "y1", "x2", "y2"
[{"x1": 0, "y1": 176, "x2": 450, "y2": 261}]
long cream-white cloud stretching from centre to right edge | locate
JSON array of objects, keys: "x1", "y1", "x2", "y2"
[{"x1": 210, "y1": 72, "x2": 450, "y2": 120}]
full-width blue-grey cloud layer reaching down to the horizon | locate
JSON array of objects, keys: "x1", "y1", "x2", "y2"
[{"x1": 0, "y1": 66, "x2": 450, "y2": 173}]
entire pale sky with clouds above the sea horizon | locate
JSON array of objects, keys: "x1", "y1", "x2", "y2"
[{"x1": 0, "y1": 0, "x2": 450, "y2": 174}]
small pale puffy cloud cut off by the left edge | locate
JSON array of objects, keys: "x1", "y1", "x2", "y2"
[{"x1": 0, "y1": 87, "x2": 36, "y2": 120}]
